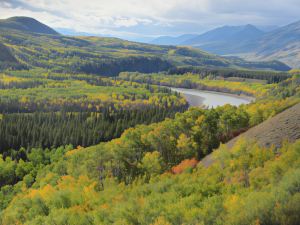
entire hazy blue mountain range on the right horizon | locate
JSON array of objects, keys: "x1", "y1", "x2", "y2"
[{"x1": 151, "y1": 21, "x2": 300, "y2": 68}]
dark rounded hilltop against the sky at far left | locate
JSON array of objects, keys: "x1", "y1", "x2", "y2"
[{"x1": 0, "y1": 16, "x2": 58, "y2": 35}]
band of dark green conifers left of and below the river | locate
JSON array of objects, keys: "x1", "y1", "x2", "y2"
[{"x1": 0, "y1": 106, "x2": 186, "y2": 153}]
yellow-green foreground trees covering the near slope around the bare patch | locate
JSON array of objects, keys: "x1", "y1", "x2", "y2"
[{"x1": 0, "y1": 73, "x2": 300, "y2": 224}]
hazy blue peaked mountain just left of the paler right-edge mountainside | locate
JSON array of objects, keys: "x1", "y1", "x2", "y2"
[{"x1": 181, "y1": 24, "x2": 264, "y2": 54}]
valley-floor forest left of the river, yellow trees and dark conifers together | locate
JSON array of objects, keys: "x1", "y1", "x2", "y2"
[{"x1": 0, "y1": 70, "x2": 188, "y2": 156}]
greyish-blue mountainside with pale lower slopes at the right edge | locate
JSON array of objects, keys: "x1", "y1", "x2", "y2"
[{"x1": 241, "y1": 21, "x2": 300, "y2": 68}]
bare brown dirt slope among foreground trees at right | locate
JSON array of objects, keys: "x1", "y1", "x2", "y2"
[{"x1": 201, "y1": 103, "x2": 300, "y2": 167}]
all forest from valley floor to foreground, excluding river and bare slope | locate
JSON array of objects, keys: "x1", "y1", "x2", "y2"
[{"x1": 0, "y1": 65, "x2": 300, "y2": 225}]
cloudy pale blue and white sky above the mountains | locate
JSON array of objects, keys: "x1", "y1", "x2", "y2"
[{"x1": 0, "y1": 0, "x2": 300, "y2": 40}]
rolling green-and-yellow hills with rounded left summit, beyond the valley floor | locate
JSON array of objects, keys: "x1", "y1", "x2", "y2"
[{"x1": 0, "y1": 17, "x2": 290, "y2": 73}]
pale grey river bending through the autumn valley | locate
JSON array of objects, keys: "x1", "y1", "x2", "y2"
[{"x1": 171, "y1": 88, "x2": 254, "y2": 108}]
